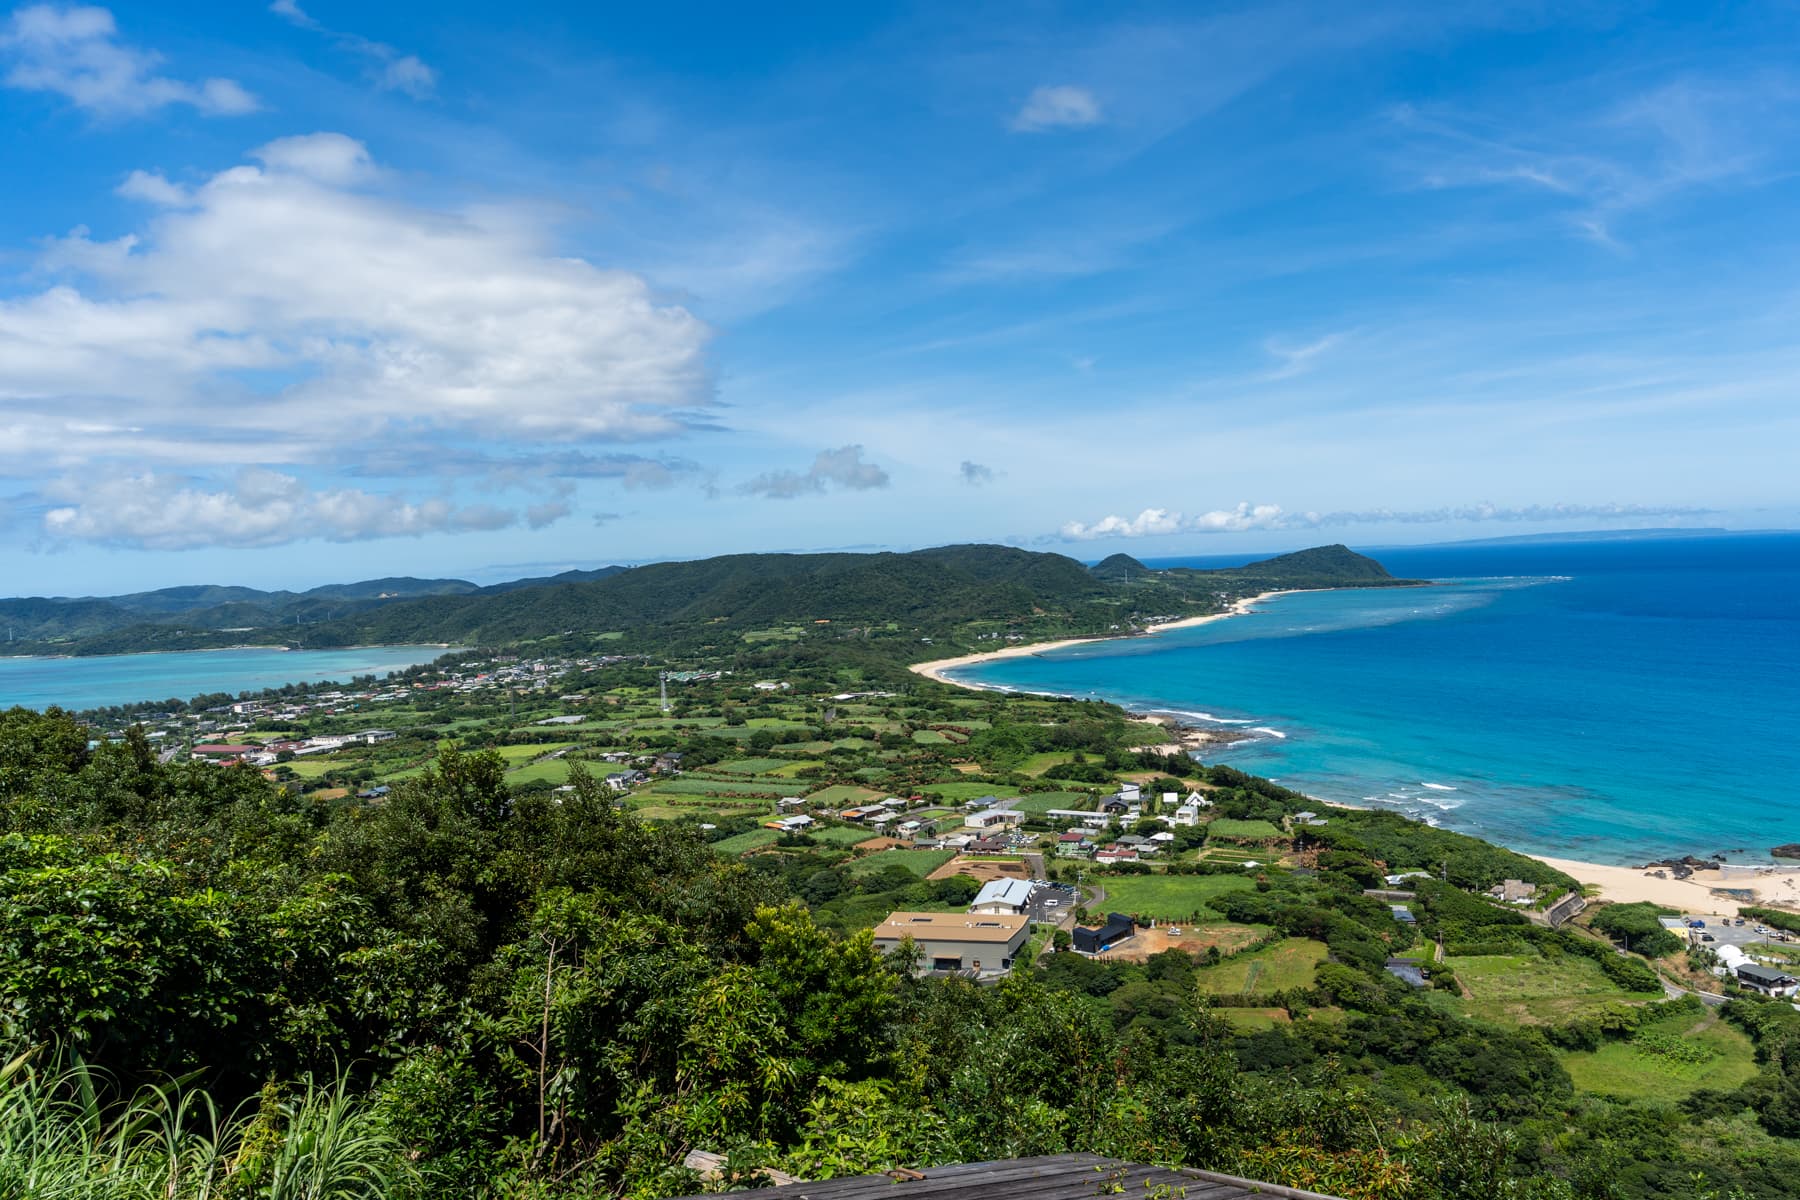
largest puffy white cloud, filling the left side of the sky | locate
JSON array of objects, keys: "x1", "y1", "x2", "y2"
[{"x1": 0, "y1": 133, "x2": 711, "y2": 468}]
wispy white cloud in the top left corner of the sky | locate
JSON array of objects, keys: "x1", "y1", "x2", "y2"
[{"x1": 0, "y1": 4, "x2": 257, "y2": 117}]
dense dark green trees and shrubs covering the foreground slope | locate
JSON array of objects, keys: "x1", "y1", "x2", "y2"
[{"x1": 0, "y1": 702, "x2": 1800, "y2": 1200}]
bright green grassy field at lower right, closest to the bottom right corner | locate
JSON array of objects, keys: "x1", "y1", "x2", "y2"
[{"x1": 1561, "y1": 1013, "x2": 1757, "y2": 1105}]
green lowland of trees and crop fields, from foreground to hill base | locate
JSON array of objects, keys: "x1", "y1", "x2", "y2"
[{"x1": 0, "y1": 546, "x2": 1800, "y2": 1200}]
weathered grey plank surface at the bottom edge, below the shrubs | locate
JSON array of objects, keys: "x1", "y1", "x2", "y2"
[{"x1": 669, "y1": 1155, "x2": 1337, "y2": 1200}]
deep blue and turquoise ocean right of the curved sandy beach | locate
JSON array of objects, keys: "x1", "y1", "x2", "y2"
[{"x1": 954, "y1": 534, "x2": 1800, "y2": 864}]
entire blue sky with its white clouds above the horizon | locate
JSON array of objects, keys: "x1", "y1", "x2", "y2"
[{"x1": 0, "y1": 0, "x2": 1800, "y2": 594}]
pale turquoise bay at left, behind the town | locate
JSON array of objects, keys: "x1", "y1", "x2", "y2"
[{"x1": 0, "y1": 646, "x2": 448, "y2": 711}]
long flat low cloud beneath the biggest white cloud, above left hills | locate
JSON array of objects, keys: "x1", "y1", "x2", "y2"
[{"x1": 43, "y1": 468, "x2": 543, "y2": 551}]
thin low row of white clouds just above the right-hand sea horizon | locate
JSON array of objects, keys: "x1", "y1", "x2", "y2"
[{"x1": 1060, "y1": 504, "x2": 1714, "y2": 542}]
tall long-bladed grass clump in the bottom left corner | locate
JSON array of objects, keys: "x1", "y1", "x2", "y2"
[{"x1": 0, "y1": 1054, "x2": 407, "y2": 1200}]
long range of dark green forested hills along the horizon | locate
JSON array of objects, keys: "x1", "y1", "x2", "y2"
[{"x1": 10, "y1": 545, "x2": 1406, "y2": 657}]
